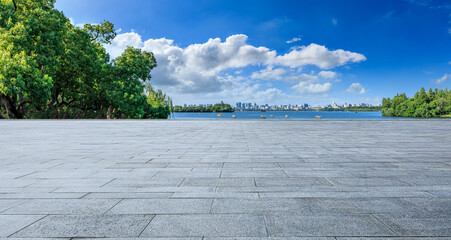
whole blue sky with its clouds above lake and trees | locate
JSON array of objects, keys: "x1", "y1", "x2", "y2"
[{"x1": 56, "y1": 0, "x2": 451, "y2": 105}]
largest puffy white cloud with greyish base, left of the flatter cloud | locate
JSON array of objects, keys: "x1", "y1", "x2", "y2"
[{"x1": 143, "y1": 34, "x2": 276, "y2": 93}]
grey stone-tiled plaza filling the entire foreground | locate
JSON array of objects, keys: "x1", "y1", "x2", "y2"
[{"x1": 0, "y1": 120, "x2": 451, "y2": 240}]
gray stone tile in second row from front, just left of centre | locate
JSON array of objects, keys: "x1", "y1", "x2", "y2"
[{"x1": 108, "y1": 199, "x2": 213, "y2": 214}]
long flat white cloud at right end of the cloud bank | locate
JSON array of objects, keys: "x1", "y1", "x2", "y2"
[{"x1": 274, "y1": 43, "x2": 366, "y2": 69}]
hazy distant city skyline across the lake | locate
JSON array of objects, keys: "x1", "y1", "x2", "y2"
[{"x1": 183, "y1": 101, "x2": 381, "y2": 110}]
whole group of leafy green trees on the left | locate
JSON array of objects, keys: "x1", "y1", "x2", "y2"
[{"x1": 0, "y1": 0, "x2": 172, "y2": 119}]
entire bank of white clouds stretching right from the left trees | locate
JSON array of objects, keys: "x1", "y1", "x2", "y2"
[{"x1": 105, "y1": 32, "x2": 366, "y2": 95}]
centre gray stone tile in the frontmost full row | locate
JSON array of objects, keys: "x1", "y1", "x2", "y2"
[{"x1": 141, "y1": 214, "x2": 266, "y2": 237}]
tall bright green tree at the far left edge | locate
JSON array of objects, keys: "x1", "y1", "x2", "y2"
[{"x1": 0, "y1": 0, "x2": 64, "y2": 118}]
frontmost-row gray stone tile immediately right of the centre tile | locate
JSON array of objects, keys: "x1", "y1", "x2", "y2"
[{"x1": 265, "y1": 214, "x2": 396, "y2": 237}]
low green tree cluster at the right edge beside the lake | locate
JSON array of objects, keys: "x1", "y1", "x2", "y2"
[{"x1": 382, "y1": 88, "x2": 451, "y2": 118}]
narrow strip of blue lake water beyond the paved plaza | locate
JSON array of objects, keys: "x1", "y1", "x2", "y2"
[{"x1": 172, "y1": 111, "x2": 404, "y2": 119}]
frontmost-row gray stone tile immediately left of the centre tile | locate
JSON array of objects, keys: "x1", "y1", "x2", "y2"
[{"x1": 12, "y1": 215, "x2": 154, "y2": 238}]
